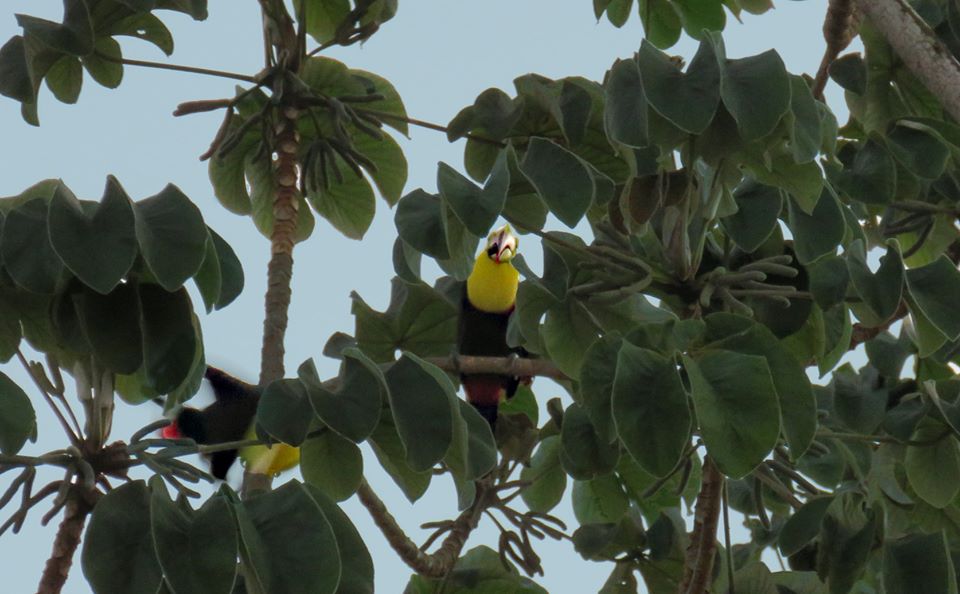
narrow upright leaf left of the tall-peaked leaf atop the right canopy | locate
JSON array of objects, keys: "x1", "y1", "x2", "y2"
[{"x1": 604, "y1": 60, "x2": 649, "y2": 148}]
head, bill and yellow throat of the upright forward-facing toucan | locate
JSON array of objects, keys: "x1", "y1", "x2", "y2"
[{"x1": 467, "y1": 225, "x2": 520, "y2": 313}]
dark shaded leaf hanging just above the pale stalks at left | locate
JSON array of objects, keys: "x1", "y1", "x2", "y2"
[{"x1": 73, "y1": 283, "x2": 143, "y2": 374}]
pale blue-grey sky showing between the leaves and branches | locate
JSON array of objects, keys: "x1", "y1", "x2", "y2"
[{"x1": 0, "y1": 0, "x2": 845, "y2": 594}]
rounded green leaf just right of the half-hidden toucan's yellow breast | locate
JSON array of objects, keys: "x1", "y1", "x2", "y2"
[{"x1": 300, "y1": 430, "x2": 363, "y2": 501}]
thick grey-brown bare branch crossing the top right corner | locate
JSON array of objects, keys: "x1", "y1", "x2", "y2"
[{"x1": 856, "y1": 0, "x2": 960, "y2": 120}]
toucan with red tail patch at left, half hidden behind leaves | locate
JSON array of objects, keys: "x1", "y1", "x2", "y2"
[{"x1": 161, "y1": 366, "x2": 300, "y2": 480}]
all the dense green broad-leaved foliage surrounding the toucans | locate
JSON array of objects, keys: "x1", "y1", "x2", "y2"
[{"x1": 0, "y1": 0, "x2": 960, "y2": 594}]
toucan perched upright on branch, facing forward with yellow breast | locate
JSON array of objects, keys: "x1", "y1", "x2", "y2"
[{"x1": 457, "y1": 225, "x2": 528, "y2": 427}]
